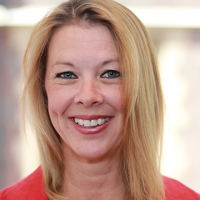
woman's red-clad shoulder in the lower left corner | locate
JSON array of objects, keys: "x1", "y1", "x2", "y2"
[{"x1": 0, "y1": 167, "x2": 47, "y2": 200}]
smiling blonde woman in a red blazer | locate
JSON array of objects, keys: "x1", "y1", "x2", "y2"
[{"x1": 0, "y1": 0, "x2": 200, "y2": 200}]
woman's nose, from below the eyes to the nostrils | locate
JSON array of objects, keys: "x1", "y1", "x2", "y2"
[{"x1": 74, "y1": 79, "x2": 103, "y2": 107}]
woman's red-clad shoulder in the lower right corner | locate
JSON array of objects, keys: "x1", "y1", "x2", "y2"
[{"x1": 163, "y1": 177, "x2": 200, "y2": 200}]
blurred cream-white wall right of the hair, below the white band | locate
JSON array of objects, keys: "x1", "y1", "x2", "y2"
[{"x1": 150, "y1": 29, "x2": 200, "y2": 192}]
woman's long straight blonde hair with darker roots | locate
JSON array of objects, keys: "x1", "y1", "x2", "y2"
[{"x1": 22, "y1": 0, "x2": 164, "y2": 200}]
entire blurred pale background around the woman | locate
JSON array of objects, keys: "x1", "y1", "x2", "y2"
[{"x1": 0, "y1": 0, "x2": 200, "y2": 193}]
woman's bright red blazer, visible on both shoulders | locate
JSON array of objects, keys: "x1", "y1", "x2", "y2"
[{"x1": 0, "y1": 167, "x2": 200, "y2": 200}]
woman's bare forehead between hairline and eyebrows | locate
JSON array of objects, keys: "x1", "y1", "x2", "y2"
[{"x1": 48, "y1": 25, "x2": 118, "y2": 65}]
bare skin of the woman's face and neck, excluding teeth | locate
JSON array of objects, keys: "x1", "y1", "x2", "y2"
[{"x1": 45, "y1": 25, "x2": 124, "y2": 200}]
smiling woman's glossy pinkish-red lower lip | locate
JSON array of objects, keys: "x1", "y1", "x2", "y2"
[{"x1": 72, "y1": 119, "x2": 111, "y2": 135}]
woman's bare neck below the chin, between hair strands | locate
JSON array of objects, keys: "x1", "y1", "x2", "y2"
[{"x1": 64, "y1": 146, "x2": 125, "y2": 200}]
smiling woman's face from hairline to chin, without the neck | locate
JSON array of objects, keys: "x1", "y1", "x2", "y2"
[{"x1": 45, "y1": 25, "x2": 123, "y2": 160}]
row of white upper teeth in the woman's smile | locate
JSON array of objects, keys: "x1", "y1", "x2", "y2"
[{"x1": 74, "y1": 117, "x2": 110, "y2": 127}]
